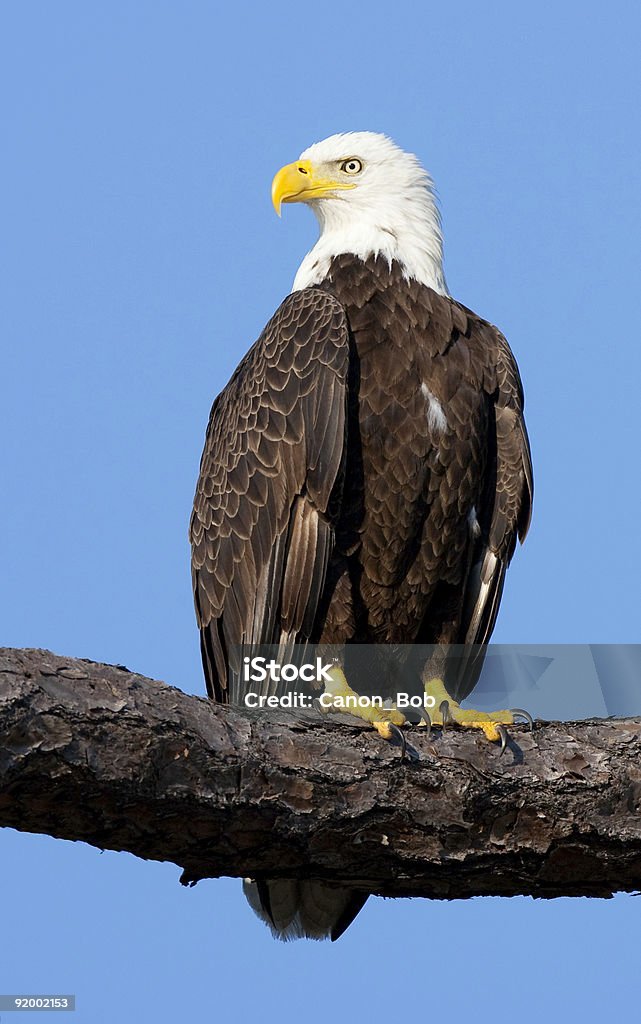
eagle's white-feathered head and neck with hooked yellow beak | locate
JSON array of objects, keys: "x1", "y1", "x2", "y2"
[{"x1": 271, "y1": 131, "x2": 447, "y2": 295}]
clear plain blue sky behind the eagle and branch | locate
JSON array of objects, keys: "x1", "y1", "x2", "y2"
[{"x1": 0, "y1": 0, "x2": 641, "y2": 1024}]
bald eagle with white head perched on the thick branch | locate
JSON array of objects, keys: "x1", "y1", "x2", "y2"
[{"x1": 190, "y1": 132, "x2": 532, "y2": 939}]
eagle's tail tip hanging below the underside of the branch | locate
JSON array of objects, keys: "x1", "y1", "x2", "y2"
[{"x1": 243, "y1": 879, "x2": 368, "y2": 942}]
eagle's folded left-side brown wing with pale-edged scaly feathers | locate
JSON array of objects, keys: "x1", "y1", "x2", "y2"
[{"x1": 189, "y1": 289, "x2": 349, "y2": 700}]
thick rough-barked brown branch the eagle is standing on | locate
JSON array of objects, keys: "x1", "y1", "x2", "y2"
[{"x1": 0, "y1": 649, "x2": 641, "y2": 898}]
